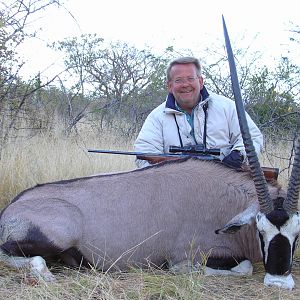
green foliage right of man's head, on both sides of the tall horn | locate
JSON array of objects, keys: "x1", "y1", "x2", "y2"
[{"x1": 203, "y1": 44, "x2": 300, "y2": 140}]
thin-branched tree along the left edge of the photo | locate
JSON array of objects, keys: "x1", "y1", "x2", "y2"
[{"x1": 0, "y1": 0, "x2": 59, "y2": 158}]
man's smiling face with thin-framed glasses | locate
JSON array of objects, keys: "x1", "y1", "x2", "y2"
[{"x1": 168, "y1": 64, "x2": 203, "y2": 113}]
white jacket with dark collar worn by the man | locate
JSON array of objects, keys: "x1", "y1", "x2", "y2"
[{"x1": 134, "y1": 87, "x2": 263, "y2": 167}]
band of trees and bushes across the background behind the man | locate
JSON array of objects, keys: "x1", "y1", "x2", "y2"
[{"x1": 0, "y1": 0, "x2": 300, "y2": 159}]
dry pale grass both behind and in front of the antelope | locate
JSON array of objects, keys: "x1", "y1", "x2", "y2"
[{"x1": 0, "y1": 127, "x2": 300, "y2": 300}]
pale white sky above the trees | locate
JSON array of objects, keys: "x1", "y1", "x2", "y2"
[{"x1": 20, "y1": 0, "x2": 300, "y2": 80}]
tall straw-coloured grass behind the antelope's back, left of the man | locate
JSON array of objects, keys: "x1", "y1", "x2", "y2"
[{"x1": 0, "y1": 132, "x2": 135, "y2": 209}]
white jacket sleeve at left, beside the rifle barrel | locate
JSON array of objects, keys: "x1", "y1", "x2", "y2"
[{"x1": 134, "y1": 111, "x2": 164, "y2": 168}]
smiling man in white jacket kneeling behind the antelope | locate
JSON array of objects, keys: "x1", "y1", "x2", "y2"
[{"x1": 134, "y1": 57, "x2": 263, "y2": 168}]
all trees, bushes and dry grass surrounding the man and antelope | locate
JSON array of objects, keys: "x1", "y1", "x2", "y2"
[{"x1": 0, "y1": 0, "x2": 300, "y2": 299}]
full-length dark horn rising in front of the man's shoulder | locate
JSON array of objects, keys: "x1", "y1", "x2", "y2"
[{"x1": 222, "y1": 16, "x2": 273, "y2": 214}]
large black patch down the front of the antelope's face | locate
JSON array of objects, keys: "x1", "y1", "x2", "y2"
[{"x1": 265, "y1": 234, "x2": 292, "y2": 275}]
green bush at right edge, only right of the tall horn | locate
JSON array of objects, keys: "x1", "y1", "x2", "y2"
[{"x1": 245, "y1": 58, "x2": 300, "y2": 137}]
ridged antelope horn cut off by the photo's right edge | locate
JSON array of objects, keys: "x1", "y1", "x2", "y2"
[{"x1": 283, "y1": 136, "x2": 300, "y2": 214}]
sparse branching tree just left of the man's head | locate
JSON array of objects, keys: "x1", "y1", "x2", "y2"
[{"x1": 53, "y1": 35, "x2": 169, "y2": 134}]
